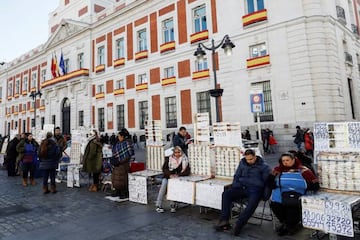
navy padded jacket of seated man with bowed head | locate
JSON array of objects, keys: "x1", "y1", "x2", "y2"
[{"x1": 232, "y1": 156, "x2": 271, "y2": 189}]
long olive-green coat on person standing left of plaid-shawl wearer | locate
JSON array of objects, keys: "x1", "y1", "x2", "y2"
[{"x1": 83, "y1": 138, "x2": 102, "y2": 173}]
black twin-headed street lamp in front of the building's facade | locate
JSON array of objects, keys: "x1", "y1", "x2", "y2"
[{"x1": 194, "y1": 35, "x2": 235, "y2": 122}]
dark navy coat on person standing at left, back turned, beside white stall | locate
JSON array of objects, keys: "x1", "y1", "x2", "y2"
[{"x1": 39, "y1": 139, "x2": 62, "y2": 170}]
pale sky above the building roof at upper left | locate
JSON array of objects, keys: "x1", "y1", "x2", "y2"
[{"x1": 0, "y1": 0, "x2": 59, "y2": 62}]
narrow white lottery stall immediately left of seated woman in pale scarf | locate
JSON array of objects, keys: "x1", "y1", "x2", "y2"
[{"x1": 128, "y1": 120, "x2": 165, "y2": 204}]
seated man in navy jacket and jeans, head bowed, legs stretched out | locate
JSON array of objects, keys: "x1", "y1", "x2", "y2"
[{"x1": 215, "y1": 149, "x2": 271, "y2": 236}]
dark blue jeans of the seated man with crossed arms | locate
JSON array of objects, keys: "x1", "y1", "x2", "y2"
[{"x1": 221, "y1": 187, "x2": 263, "y2": 228}]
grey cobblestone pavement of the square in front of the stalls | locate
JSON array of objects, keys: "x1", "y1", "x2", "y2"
[{"x1": 0, "y1": 149, "x2": 318, "y2": 240}]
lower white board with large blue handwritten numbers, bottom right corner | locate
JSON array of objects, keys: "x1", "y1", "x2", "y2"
[{"x1": 301, "y1": 192, "x2": 360, "y2": 237}]
